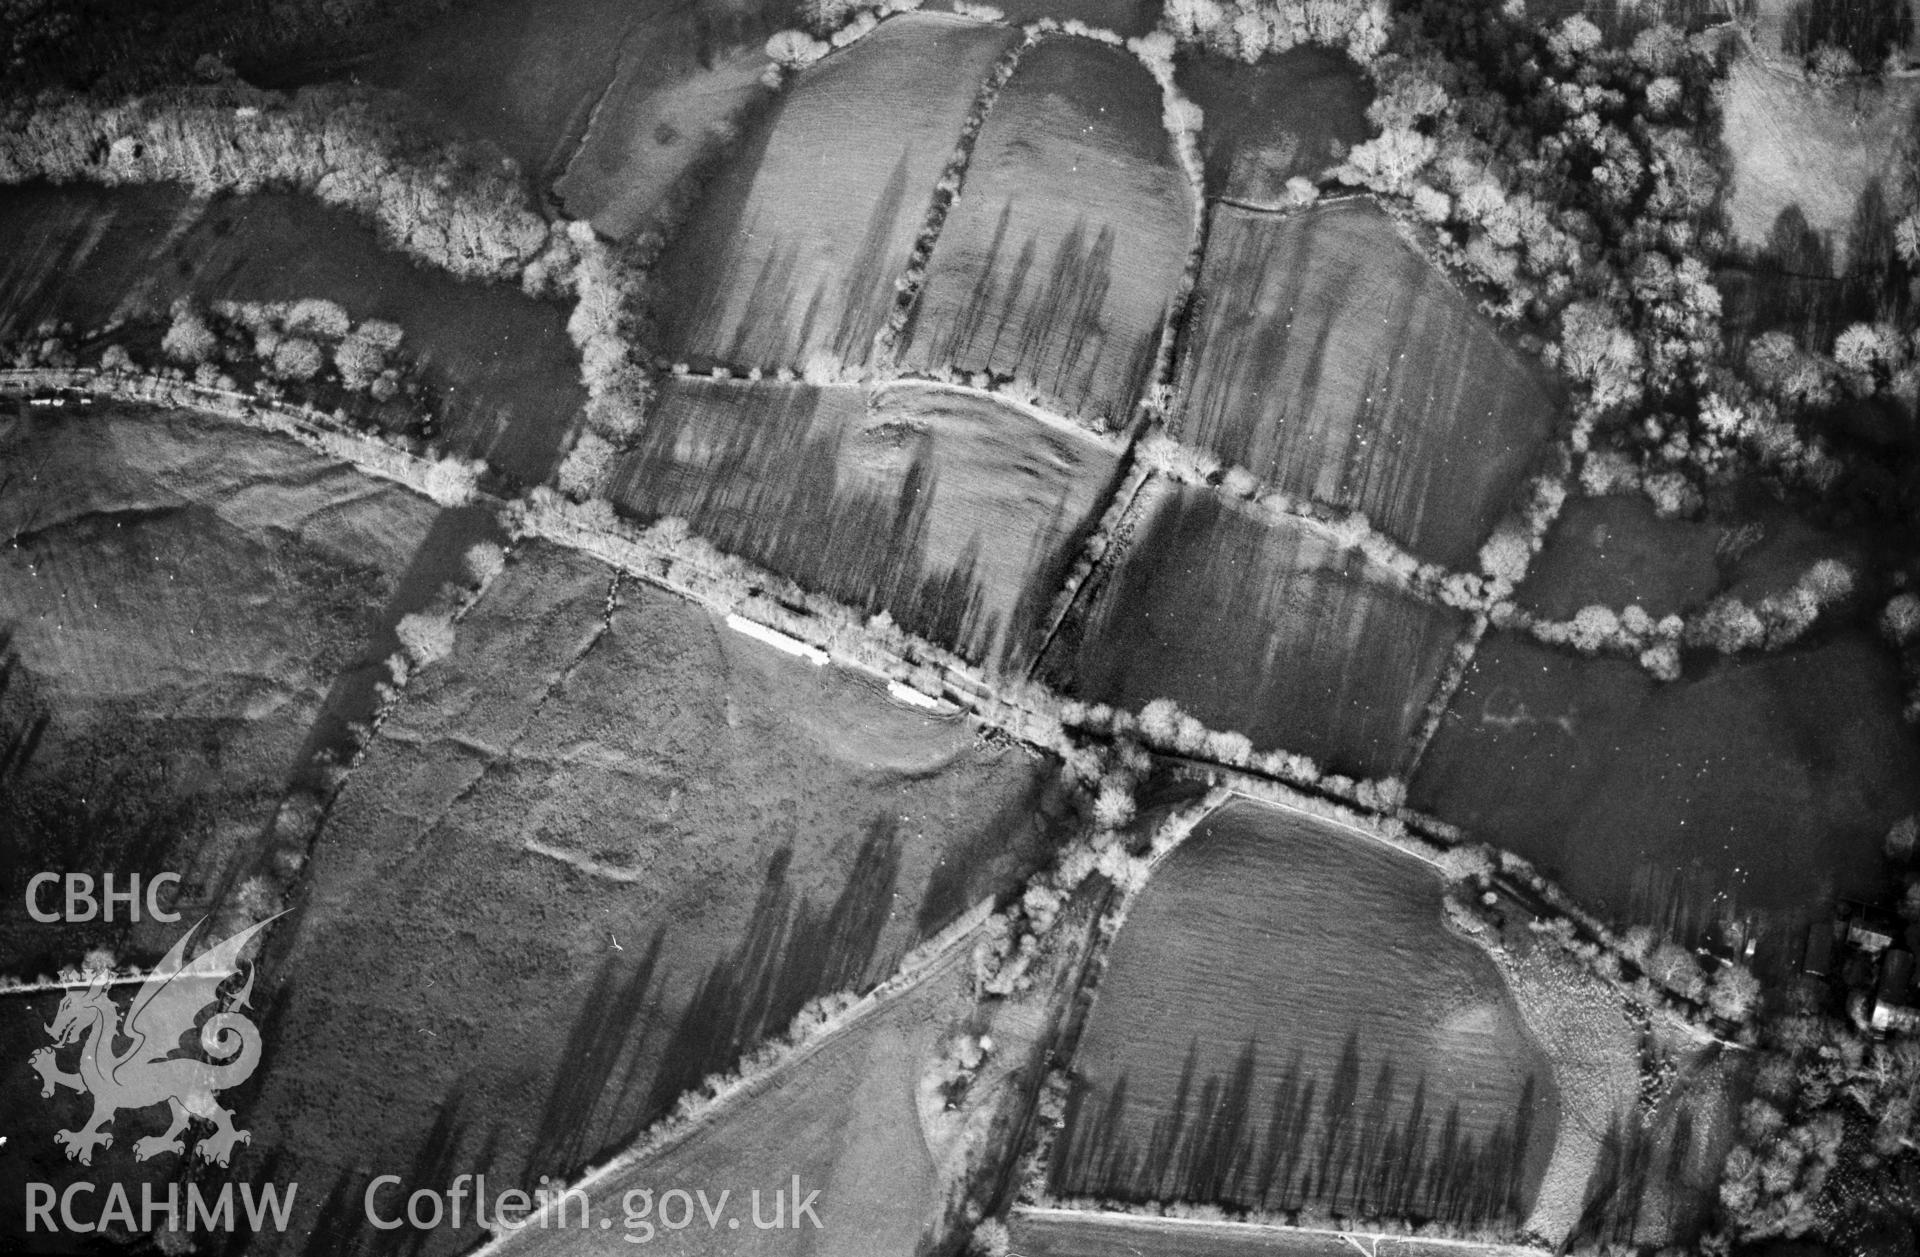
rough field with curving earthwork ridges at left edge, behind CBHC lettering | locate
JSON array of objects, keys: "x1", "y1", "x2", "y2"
[{"x1": 0, "y1": 407, "x2": 438, "y2": 977}]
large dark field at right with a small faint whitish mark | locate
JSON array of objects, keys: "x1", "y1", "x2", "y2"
[{"x1": 1413, "y1": 633, "x2": 1920, "y2": 965}]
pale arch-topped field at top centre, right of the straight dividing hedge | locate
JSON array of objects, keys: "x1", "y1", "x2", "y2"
[{"x1": 900, "y1": 38, "x2": 1194, "y2": 424}]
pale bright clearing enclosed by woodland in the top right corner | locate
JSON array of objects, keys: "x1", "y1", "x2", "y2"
[{"x1": 1720, "y1": 58, "x2": 1920, "y2": 267}]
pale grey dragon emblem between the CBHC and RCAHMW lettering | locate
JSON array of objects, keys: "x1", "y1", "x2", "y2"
[{"x1": 29, "y1": 917, "x2": 278, "y2": 1165}]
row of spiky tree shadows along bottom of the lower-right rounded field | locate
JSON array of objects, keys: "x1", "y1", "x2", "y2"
[{"x1": 1048, "y1": 1034, "x2": 1538, "y2": 1228}]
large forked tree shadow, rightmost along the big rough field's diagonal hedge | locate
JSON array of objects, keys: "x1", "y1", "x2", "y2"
[{"x1": 645, "y1": 818, "x2": 900, "y2": 1115}]
